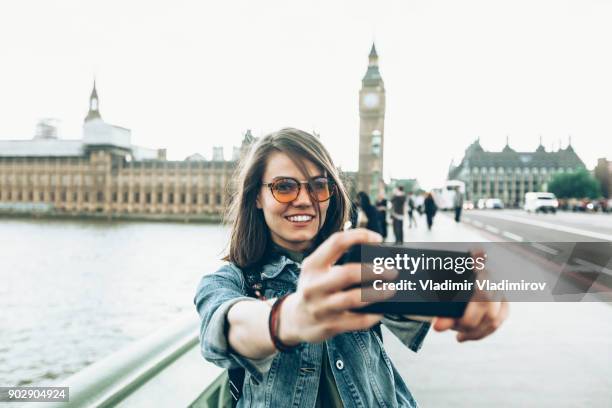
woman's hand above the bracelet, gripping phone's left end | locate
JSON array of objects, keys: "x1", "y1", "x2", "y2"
[{"x1": 279, "y1": 228, "x2": 393, "y2": 345}]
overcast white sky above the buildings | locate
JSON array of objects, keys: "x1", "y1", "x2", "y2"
[{"x1": 0, "y1": 0, "x2": 612, "y2": 187}]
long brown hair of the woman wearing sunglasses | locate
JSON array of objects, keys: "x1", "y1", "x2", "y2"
[{"x1": 223, "y1": 128, "x2": 350, "y2": 268}]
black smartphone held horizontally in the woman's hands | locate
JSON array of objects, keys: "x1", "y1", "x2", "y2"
[{"x1": 336, "y1": 244, "x2": 475, "y2": 320}]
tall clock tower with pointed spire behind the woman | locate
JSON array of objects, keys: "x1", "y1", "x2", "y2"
[{"x1": 357, "y1": 44, "x2": 385, "y2": 199}]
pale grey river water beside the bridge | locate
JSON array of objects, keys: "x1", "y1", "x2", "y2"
[{"x1": 0, "y1": 219, "x2": 228, "y2": 386}]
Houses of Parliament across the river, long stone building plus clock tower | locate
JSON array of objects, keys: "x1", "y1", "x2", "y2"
[{"x1": 0, "y1": 45, "x2": 385, "y2": 220}]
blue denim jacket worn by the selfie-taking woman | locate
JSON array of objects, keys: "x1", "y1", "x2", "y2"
[{"x1": 194, "y1": 256, "x2": 430, "y2": 408}]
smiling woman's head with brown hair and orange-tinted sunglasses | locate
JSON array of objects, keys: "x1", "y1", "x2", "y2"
[{"x1": 225, "y1": 129, "x2": 349, "y2": 268}]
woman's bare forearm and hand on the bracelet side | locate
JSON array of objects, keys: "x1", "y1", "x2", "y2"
[{"x1": 227, "y1": 229, "x2": 393, "y2": 359}]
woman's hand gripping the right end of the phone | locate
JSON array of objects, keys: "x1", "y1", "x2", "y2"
[{"x1": 433, "y1": 251, "x2": 509, "y2": 342}]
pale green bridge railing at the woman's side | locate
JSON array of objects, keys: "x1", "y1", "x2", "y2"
[{"x1": 49, "y1": 313, "x2": 230, "y2": 408}]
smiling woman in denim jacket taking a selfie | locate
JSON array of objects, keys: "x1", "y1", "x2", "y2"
[{"x1": 194, "y1": 129, "x2": 504, "y2": 407}]
